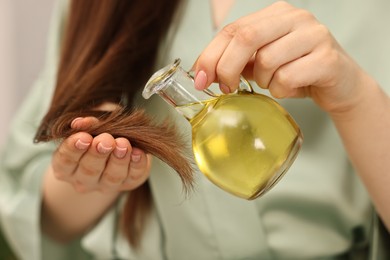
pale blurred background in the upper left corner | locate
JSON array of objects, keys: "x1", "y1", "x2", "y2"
[{"x1": 0, "y1": 0, "x2": 56, "y2": 146}]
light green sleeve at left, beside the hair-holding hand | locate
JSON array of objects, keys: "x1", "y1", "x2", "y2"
[{"x1": 0, "y1": 0, "x2": 86, "y2": 259}]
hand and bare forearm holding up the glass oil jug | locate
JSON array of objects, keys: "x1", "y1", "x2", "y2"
[{"x1": 194, "y1": 2, "x2": 390, "y2": 230}]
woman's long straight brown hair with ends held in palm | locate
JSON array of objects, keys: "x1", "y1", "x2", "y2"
[{"x1": 35, "y1": 0, "x2": 193, "y2": 247}]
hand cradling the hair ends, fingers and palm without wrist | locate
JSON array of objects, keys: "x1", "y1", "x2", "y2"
[{"x1": 52, "y1": 117, "x2": 151, "y2": 193}]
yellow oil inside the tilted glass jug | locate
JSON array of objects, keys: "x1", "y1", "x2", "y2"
[{"x1": 176, "y1": 92, "x2": 302, "y2": 199}]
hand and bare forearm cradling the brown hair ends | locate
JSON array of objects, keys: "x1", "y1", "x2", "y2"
[{"x1": 42, "y1": 114, "x2": 151, "y2": 242}]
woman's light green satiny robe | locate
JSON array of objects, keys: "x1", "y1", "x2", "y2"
[{"x1": 0, "y1": 0, "x2": 390, "y2": 260}]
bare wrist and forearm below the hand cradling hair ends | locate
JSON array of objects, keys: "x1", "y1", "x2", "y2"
[{"x1": 41, "y1": 167, "x2": 121, "y2": 242}]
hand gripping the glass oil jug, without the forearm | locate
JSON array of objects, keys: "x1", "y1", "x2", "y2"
[{"x1": 194, "y1": 2, "x2": 368, "y2": 116}]
